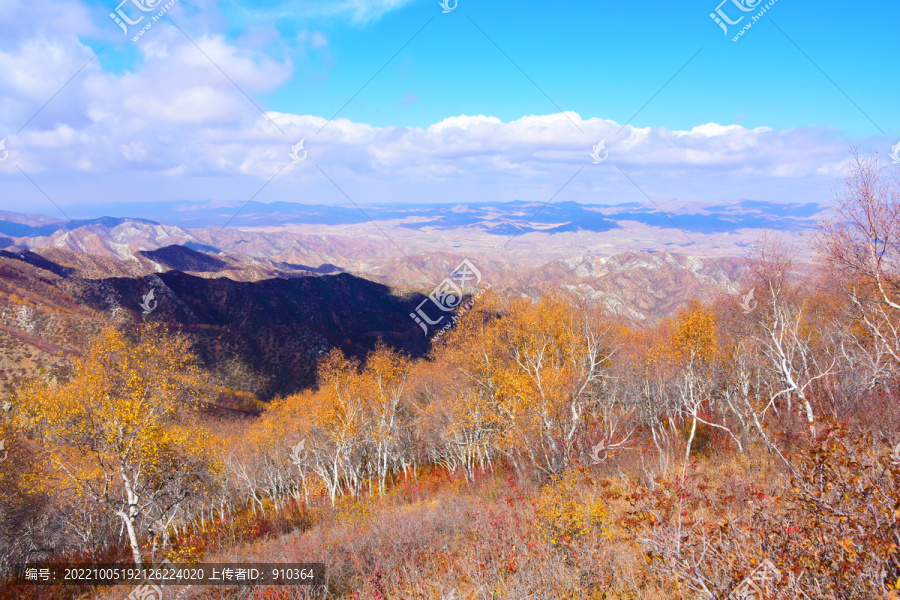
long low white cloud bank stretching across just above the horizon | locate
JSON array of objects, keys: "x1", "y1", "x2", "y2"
[{"x1": 4, "y1": 95, "x2": 850, "y2": 200}]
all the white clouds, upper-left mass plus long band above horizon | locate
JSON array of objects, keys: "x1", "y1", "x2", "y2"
[{"x1": 0, "y1": 0, "x2": 872, "y2": 207}]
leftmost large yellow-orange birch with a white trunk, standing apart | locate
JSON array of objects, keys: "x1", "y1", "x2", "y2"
[{"x1": 19, "y1": 326, "x2": 213, "y2": 566}]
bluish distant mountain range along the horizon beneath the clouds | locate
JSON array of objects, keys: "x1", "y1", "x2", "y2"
[{"x1": 15, "y1": 200, "x2": 823, "y2": 237}]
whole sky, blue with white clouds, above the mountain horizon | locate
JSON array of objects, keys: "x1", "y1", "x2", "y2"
[{"x1": 0, "y1": 0, "x2": 900, "y2": 212}]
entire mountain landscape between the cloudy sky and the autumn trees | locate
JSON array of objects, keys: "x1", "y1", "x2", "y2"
[{"x1": 0, "y1": 201, "x2": 823, "y2": 406}]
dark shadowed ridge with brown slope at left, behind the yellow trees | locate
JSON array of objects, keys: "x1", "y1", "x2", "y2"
[{"x1": 0, "y1": 251, "x2": 427, "y2": 399}]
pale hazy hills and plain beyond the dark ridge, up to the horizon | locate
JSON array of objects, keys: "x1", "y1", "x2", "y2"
[{"x1": 0, "y1": 200, "x2": 824, "y2": 270}]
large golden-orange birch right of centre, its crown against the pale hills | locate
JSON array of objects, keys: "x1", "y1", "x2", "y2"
[{"x1": 430, "y1": 293, "x2": 617, "y2": 475}]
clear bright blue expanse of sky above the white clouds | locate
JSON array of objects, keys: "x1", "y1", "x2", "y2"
[{"x1": 248, "y1": 0, "x2": 900, "y2": 137}]
